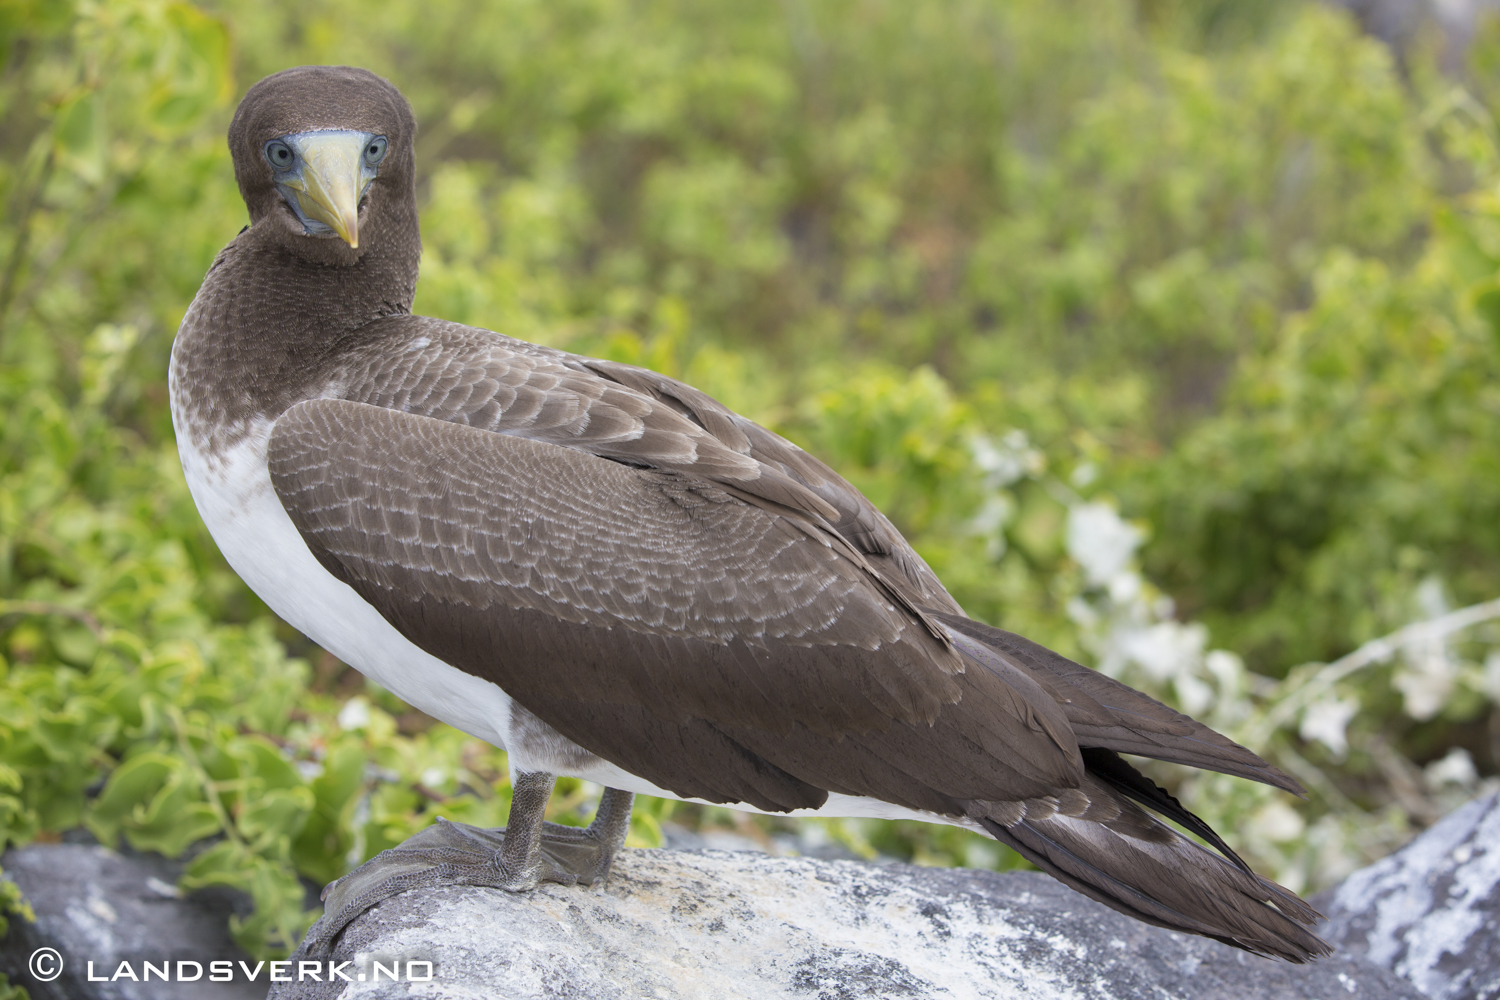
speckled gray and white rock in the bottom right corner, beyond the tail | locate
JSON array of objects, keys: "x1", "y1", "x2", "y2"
[{"x1": 1320, "y1": 793, "x2": 1500, "y2": 1000}]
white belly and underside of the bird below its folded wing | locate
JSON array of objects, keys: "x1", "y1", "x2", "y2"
[{"x1": 177, "y1": 404, "x2": 978, "y2": 829}]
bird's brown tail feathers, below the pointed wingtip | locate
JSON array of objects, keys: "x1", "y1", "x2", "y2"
[{"x1": 974, "y1": 774, "x2": 1332, "y2": 963}]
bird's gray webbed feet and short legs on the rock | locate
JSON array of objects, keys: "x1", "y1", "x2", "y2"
[{"x1": 296, "y1": 772, "x2": 635, "y2": 957}]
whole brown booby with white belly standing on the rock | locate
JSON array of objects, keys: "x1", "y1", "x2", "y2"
[{"x1": 171, "y1": 66, "x2": 1329, "y2": 961}]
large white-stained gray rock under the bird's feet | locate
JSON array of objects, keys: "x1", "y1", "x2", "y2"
[{"x1": 270, "y1": 850, "x2": 1421, "y2": 1000}]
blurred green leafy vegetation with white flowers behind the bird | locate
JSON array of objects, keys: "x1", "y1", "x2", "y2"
[{"x1": 0, "y1": 0, "x2": 1500, "y2": 971}]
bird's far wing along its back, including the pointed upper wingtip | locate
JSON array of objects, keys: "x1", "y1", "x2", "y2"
[{"x1": 322, "y1": 316, "x2": 1302, "y2": 793}]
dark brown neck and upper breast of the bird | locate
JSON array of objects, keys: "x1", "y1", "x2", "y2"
[{"x1": 171, "y1": 226, "x2": 420, "y2": 452}]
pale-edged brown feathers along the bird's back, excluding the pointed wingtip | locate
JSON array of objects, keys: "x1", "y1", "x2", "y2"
[{"x1": 336, "y1": 316, "x2": 960, "y2": 617}]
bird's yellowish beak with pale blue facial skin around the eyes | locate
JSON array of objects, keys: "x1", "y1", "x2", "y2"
[{"x1": 264, "y1": 129, "x2": 387, "y2": 246}]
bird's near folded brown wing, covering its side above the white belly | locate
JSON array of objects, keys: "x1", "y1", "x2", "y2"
[{"x1": 269, "y1": 400, "x2": 1082, "y2": 813}]
